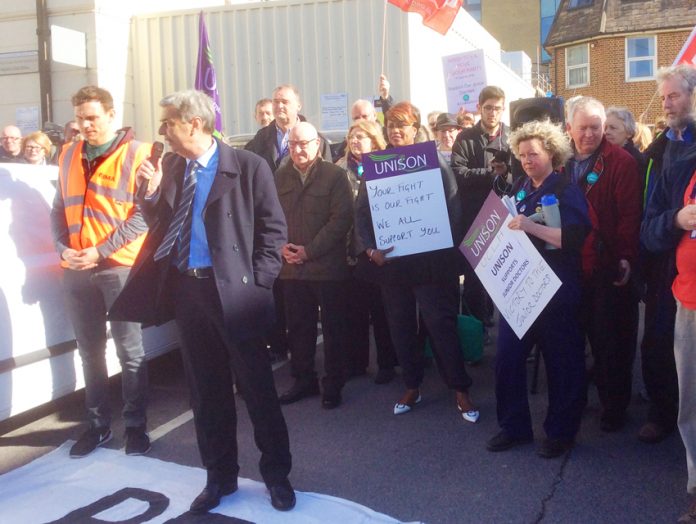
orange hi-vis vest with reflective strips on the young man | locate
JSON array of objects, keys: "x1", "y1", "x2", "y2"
[{"x1": 58, "y1": 140, "x2": 151, "y2": 267}]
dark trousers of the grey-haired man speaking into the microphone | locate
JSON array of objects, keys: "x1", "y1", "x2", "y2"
[{"x1": 177, "y1": 270, "x2": 292, "y2": 486}]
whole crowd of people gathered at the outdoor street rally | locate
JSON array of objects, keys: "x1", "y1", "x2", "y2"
[{"x1": 0, "y1": 61, "x2": 696, "y2": 522}]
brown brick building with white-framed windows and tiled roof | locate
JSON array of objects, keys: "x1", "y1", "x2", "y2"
[{"x1": 545, "y1": 0, "x2": 696, "y2": 124}]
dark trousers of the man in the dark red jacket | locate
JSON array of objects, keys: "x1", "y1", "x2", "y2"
[{"x1": 581, "y1": 273, "x2": 638, "y2": 418}]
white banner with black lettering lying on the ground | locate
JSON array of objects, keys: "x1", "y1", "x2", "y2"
[{"x1": 0, "y1": 442, "x2": 418, "y2": 524}]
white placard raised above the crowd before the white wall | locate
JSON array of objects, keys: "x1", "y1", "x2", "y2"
[{"x1": 442, "y1": 49, "x2": 487, "y2": 115}]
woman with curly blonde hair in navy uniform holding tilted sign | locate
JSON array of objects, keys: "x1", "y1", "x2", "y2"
[{"x1": 487, "y1": 121, "x2": 590, "y2": 458}]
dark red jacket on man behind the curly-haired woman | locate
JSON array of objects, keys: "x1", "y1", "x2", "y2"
[{"x1": 578, "y1": 138, "x2": 641, "y2": 276}]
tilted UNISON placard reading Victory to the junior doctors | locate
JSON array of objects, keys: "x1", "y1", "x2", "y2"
[{"x1": 459, "y1": 191, "x2": 561, "y2": 338}]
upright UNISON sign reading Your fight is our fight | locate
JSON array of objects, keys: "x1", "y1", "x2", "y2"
[{"x1": 363, "y1": 142, "x2": 454, "y2": 257}]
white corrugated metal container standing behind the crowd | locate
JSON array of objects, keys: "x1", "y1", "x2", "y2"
[{"x1": 130, "y1": 0, "x2": 532, "y2": 139}]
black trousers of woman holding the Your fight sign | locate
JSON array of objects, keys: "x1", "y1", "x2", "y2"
[{"x1": 382, "y1": 282, "x2": 471, "y2": 391}]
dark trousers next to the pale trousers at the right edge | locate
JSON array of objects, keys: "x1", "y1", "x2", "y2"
[{"x1": 640, "y1": 274, "x2": 679, "y2": 431}]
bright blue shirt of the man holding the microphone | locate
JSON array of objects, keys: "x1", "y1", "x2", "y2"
[{"x1": 186, "y1": 140, "x2": 220, "y2": 268}]
